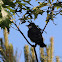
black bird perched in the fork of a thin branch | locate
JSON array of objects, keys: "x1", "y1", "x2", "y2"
[{"x1": 27, "y1": 22, "x2": 46, "y2": 47}]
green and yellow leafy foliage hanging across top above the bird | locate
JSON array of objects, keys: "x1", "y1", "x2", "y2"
[{"x1": 0, "y1": 0, "x2": 62, "y2": 31}]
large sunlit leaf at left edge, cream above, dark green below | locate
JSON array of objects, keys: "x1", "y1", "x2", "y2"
[{"x1": 0, "y1": 7, "x2": 11, "y2": 31}]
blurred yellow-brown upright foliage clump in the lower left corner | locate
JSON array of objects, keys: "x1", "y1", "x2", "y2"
[{"x1": 0, "y1": 28, "x2": 19, "y2": 62}]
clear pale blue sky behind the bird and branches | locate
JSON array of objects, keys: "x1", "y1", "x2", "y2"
[{"x1": 0, "y1": 1, "x2": 62, "y2": 62}]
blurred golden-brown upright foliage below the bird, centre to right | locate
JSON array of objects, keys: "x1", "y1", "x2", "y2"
[{"x1": 24, "y1": 37, "x2": 60, "y2": 62}]
